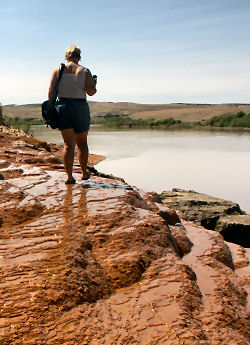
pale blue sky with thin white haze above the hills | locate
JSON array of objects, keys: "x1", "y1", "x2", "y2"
[{"x1": 0, "y1": 0, "x2": 250, "y2": 105}]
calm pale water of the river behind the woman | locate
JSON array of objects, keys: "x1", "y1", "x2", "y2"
[{"x1": 31, "y1": 126, "x2": 250, "y2": 213}]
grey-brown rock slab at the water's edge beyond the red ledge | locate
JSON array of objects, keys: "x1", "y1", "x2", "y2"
[{"x1": 160, "y1": 188, "x2": 250, "y2": 248}]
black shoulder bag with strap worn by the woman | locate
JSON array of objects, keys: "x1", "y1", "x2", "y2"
[{"x1": 42, "y1": 63, "x2": 65, "y2": 129}]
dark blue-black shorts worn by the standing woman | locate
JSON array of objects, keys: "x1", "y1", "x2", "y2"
[{"x1": 56, "y1": 98, "x2": 90, "y2": 133}]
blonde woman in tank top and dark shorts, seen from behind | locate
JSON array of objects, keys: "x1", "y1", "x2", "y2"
[{"x1": 48, "y1": 45, "x2": 96, "y2": 184}]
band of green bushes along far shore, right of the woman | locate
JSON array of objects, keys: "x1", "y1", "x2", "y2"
[{"x1": 92, "y1": 111, "x2": 250, "y2": 129}]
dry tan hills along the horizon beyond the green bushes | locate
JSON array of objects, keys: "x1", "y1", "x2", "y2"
[{"x1": 3, "y1": 101, "x2": 250, "y2": 122}]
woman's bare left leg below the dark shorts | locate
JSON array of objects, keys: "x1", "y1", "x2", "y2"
[{"x1": 61, "y1": 128, "x2": 76, "y2": 182}]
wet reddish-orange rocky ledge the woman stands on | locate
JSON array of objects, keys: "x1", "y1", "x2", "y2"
[{"x1": 0, "y1": 126, "x2": 250, "y2": 345}]
